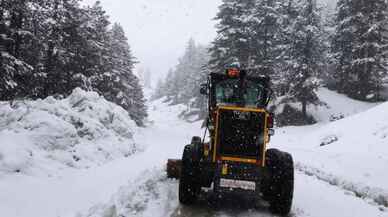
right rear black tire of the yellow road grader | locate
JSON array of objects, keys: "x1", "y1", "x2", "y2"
[{"x1": 263, "y1": 149, "x2": 294, "y2": 215}]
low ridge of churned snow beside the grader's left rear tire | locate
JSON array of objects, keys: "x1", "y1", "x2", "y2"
[{"x1": 84, "y1": 169, "x2": 178, "y2": 217}]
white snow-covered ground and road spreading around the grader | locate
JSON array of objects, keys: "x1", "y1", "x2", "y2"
[{"x1": 0, "y1": 87, "x2": 388, "y2": 217}]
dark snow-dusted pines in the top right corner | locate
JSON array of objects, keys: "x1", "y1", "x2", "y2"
[{"x1": 332, "y1": 0, "x2": 388, "y2": 101}]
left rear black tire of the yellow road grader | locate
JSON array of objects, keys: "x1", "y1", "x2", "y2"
[{"x1": 179, "y1": 145, "x2": 201, "y2": 205}]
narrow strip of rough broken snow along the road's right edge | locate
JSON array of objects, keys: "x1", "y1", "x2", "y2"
[{"x1": 295, "y1": 162, "x2": 388, "y2": 212}]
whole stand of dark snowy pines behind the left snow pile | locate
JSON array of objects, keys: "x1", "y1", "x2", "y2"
[{"x1": 0, "y1": 0, "x2": 147, "y2": 125}]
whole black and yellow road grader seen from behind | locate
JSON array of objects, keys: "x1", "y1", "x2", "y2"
[{"x1": 167, "y1": 67, "x2": 294, "y2": 214}]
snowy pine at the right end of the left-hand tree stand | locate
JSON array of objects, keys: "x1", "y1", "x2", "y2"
[{"x1": 97, "y1": 23, "x2": 147, "y2": 126}]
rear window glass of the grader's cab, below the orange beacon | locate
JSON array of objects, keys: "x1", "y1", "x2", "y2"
[{"x1": 215, "y1": 79, "x2": 264, "y2": 107}]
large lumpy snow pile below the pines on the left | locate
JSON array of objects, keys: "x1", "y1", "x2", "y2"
[{"x1": 0, "y1": 89, "x2": 141, "y2": 174}]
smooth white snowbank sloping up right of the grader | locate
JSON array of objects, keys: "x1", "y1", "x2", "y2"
[{"x1": 272, "y1": 103, "x2": 388, "y2": 207}]
